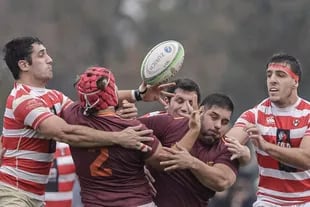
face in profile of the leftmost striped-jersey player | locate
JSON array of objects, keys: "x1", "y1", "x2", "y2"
[{"x1": 28, "y1": 43, "x2": 53, "y2": 86}]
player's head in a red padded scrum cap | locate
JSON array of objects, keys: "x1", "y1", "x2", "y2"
[{"x1": 75, "y1": 67, "x2": 118, "y2": 115}]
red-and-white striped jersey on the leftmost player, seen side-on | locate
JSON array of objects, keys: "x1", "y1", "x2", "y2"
[{"x1": 0, "y1": 83, "x2": 72, "y2": 200}]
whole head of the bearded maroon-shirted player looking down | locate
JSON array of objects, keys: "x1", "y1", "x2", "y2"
[{"x1": 199, "y1": 93, "x2": 234, "y2": 144}]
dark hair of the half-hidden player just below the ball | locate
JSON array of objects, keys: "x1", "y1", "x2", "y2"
[{"x1": 167, "y1": 78, "x2": 201, "y2": 103}]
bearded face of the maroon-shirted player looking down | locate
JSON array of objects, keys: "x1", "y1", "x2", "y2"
[{"x1": 199, "y1": 105, "x2": 231, "y2": 144}]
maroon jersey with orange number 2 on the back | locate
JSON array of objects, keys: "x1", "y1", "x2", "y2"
[{"x1": 63, "y1": 104, "x2": 159, "y2": 207}]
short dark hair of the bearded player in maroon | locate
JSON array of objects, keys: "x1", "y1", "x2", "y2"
[{"x1": 200, "y1": 93, "x2": 234, "y2": 113}]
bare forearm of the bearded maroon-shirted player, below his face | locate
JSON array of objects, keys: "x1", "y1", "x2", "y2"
[{"x1": 190, "y1": 158, "x2": 231, "y2": 192}]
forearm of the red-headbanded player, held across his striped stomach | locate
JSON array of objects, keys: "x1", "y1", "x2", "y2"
[{"x1": 264, "y1": 143, "x2": 310, "y2": 170}]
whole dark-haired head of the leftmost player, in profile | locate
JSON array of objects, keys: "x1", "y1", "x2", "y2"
[{"x1": 3, "y1": 37, "x2": 53, "y2": 82}]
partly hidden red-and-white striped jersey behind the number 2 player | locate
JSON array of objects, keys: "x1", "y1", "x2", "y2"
[{"x1": 45, "y1": 142, "x2": 76, "y2": 207}]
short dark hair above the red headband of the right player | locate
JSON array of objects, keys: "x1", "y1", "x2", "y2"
[{"x1": 266, "y1": 53, "x2": 302, "y2": 82}]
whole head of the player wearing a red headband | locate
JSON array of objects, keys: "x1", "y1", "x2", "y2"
[{"x1": 266, "y1": 54, "x2": 302, "y2": 107}]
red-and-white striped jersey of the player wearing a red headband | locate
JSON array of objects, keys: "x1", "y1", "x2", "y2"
[{"x1": 235, "y1": 98, "x2": 310, "y2": 206}]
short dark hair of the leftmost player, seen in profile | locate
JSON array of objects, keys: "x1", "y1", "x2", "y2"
[{"x1": 3, "y1": 36, "x2": 43, "y2": 80}]
